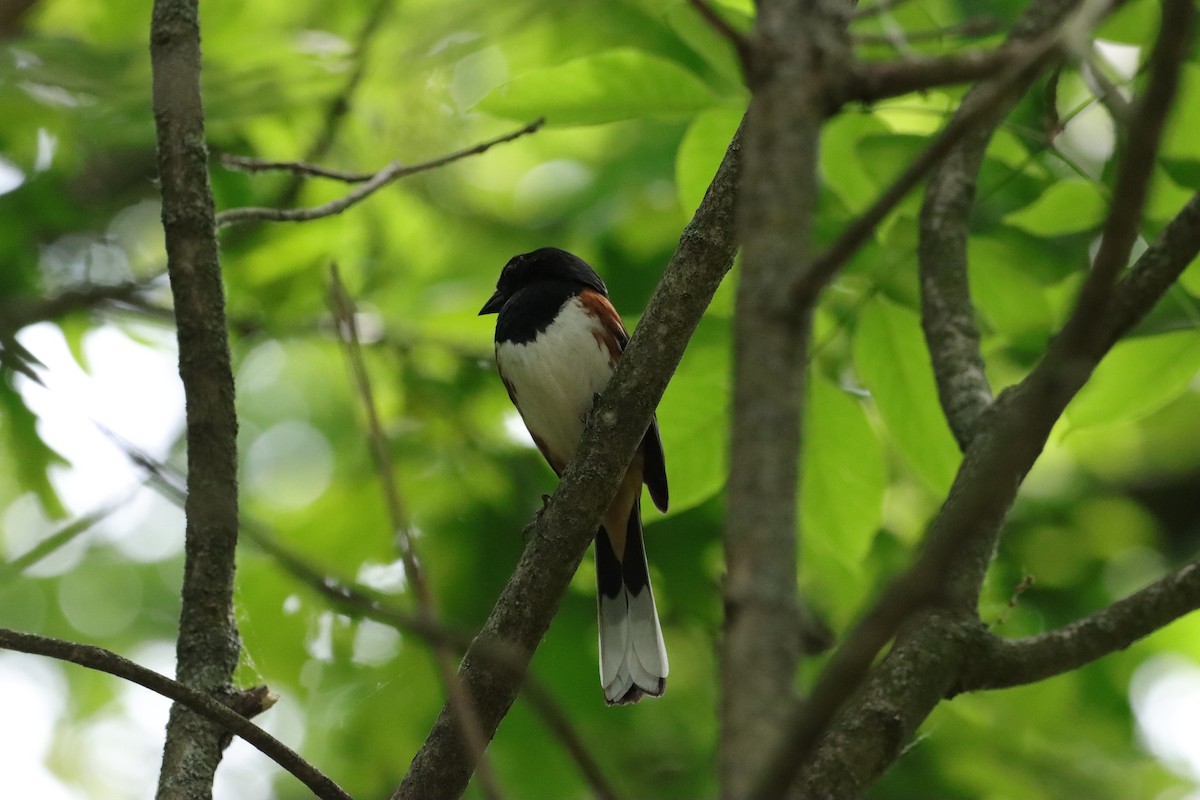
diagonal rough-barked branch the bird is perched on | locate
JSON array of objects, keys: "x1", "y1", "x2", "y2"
[{"x1": 392, "y1": 117, "x2": 740, "y2": 800}]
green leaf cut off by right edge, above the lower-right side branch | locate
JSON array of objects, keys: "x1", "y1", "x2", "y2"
[{"x1": 1067, "y1": 330, "x2": 1200, "y2": 428}]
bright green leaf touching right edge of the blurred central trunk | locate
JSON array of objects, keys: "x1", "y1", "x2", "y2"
[{"x1": 800, "y1": 374, "x2": 887, "y2": 584}]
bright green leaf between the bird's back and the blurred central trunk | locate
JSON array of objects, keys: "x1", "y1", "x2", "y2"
[{"x1": 659, "y1": 317, "x2": 730, "y2": 515}]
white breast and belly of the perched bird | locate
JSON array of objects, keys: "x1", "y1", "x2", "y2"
[{"x1": 496, "y1": 297, "x2": 612, "y2": 464}]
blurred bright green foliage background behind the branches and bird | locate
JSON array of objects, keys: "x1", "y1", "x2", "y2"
[{"x1": 0, "y1": 0, "x2": 1200, "y2": 799}]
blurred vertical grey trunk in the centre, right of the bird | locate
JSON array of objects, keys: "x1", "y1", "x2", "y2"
[{"x1": 718, "y1": 0, "x2": 850, "y2": 798}]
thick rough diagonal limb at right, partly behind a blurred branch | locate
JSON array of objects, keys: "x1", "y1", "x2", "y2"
[{"x1": 782, "y1": 59, "x2": 1200, "y2": 796}]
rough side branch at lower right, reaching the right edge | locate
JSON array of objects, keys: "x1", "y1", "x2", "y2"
[{"x1": 953, "y1": 563, "x2": 1200, "y2": 693}]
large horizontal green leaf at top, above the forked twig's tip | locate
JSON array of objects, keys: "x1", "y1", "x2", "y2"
[{"x1": 479, "y1": 48, "x2": 714, "y2": 125}]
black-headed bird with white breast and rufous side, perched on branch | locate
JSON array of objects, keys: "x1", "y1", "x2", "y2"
[{"x1": 479, "y1": 247, "x2": 668, "y2": 705}]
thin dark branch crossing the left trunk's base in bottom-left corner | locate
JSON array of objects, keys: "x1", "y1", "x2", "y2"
[{"x1": 0, "y1": 628, "x2": 350, "y2": 800}]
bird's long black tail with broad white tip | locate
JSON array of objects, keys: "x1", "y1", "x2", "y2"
[{"x1": 596, "y1": 501, "x2": 668, "y2": 705}]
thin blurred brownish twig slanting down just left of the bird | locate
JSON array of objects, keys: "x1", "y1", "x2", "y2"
[{"x1": 329, "y1": 264, "x2": 502, "y2": 799}]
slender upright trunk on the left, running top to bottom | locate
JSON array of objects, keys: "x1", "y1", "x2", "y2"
[{"x1": 150, "y1": 0, "x2": 240, "y2": 800}]
